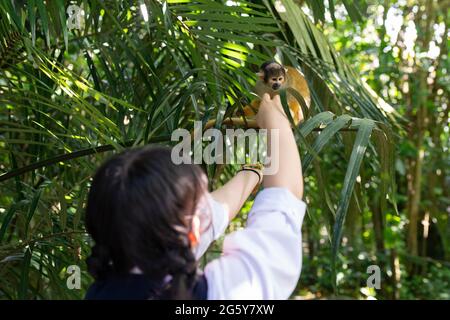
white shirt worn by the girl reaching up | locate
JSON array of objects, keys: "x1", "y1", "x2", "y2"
[{"x1": 195, "y1": 188, "x2": 306, "y2": 300}]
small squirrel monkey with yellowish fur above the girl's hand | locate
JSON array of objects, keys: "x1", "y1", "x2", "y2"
[{"x1": 244, "y1": 61, "x2": 311, "y2": 124}]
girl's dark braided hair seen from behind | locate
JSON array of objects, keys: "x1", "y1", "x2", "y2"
[{"x1": 86, "y1": 147, "x2": 207, "y2": 299}]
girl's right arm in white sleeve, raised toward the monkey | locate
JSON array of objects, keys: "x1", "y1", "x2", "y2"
[{"x1": 205, "y1": 95, "x2": 306, "y2": 299}]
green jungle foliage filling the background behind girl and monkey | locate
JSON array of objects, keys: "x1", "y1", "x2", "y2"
[{"x1": 0, "y1": 0, "x2": 450, "y2": 299}]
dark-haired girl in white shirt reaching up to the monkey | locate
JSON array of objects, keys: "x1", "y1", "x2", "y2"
[{"x1": 86, "y1": 95, "x2": 306, "y2": 299}]
